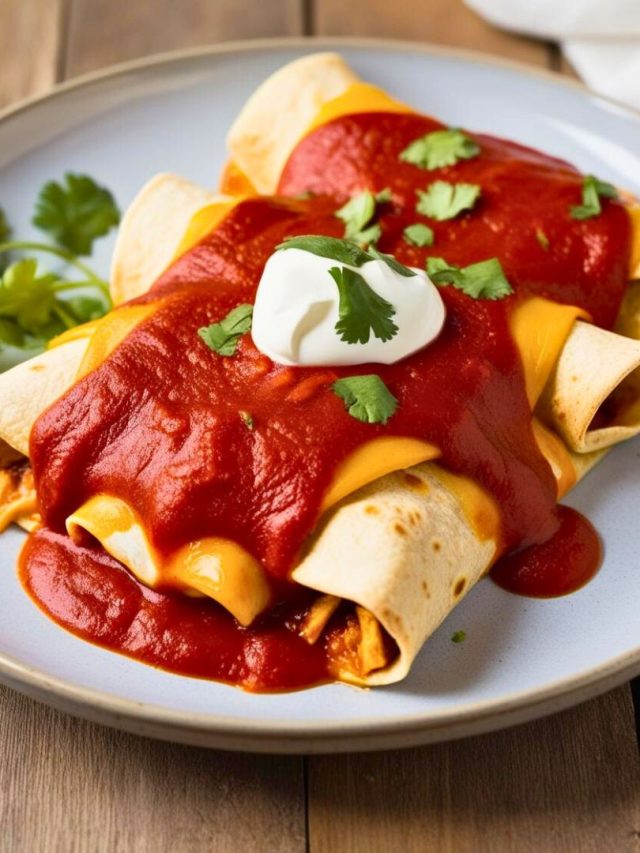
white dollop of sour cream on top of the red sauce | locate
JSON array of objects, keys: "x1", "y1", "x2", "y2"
[{"x1": 251, "y1": 248, "x2": 445, "y2": 367}]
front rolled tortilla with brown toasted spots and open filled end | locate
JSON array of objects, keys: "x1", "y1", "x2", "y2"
[{"x1": 292, "y1": 462, "x2": 499, "y2": 686}]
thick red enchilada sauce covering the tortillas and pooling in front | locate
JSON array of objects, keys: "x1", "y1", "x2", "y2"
[{"x1": 22, "y1": 114, "x2": 631, "y2": 689}]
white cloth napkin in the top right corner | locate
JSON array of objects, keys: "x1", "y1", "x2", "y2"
[{"x1": 465, "y1": 0, "x2": 640, "y2": 108}]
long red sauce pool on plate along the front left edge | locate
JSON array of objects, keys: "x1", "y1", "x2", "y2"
[{"x1": 20, "y1": 529, "x2": 331, "y2": 692}]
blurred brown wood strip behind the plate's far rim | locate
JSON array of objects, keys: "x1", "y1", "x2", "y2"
[{"x1": 0, "y1": 0, "x2": 576, "y2": 106}]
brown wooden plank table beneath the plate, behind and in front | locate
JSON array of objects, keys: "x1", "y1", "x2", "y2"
[{"x1": 0, "y1": 0, "x2": 640, "y2": 853}]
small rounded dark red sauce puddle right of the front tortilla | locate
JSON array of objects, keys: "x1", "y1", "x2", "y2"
[{"x1": 491, "y1": 506, "x2": 602, "y2": 598}]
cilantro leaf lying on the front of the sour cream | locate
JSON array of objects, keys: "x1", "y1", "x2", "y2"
[{"x1": 329, "y1": 267, "x2": 398, "y2": 344}]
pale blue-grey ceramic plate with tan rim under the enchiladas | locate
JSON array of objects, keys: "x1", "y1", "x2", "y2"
[{"x1": 0, "y1": 40, "x2": 640, "y2": 752}]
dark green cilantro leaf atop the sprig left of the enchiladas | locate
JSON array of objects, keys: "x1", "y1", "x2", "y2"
[{"x1": 33, "y1": 173, "x2": 120, "y2": 255}]
